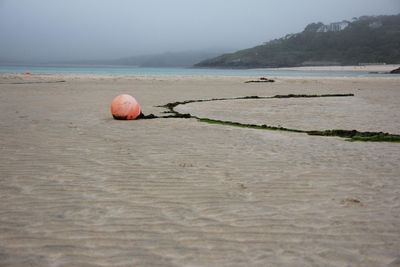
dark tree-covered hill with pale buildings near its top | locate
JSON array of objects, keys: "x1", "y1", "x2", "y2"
[{"x1": 195, "y1": 14, "x2": 400, "y2": 68}]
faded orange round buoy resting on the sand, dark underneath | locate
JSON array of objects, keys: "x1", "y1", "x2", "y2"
[{"x1": 111, "y1": 94, "x2": 141, "y2": 120}]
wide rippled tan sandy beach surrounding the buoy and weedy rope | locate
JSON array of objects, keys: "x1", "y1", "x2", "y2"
[{"x1": 0, "y1": 74, "x2": 400, "y2": 267}]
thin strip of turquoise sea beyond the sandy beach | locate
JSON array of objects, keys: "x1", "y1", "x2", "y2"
[{"x1": 0, "y1": 66, "x2": 389, "y2": 77}]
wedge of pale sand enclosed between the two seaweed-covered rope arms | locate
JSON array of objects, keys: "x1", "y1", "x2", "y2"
[{"x1": 175, "y1": 93, "x2": 400, "y2": 133}]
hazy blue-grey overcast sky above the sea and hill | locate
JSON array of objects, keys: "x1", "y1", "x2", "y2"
[{"x1": 0, "y1": 0, "x2": 400, "y2": 61}]
